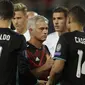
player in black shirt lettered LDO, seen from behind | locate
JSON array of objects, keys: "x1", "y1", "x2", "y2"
[{"x1": 0, "y1": 0, "x2": 37, "y2": 85}]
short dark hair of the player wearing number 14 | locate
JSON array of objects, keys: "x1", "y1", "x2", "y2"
[{"x1": 68, "y1": 5, "x2": 85, "y2": 25}]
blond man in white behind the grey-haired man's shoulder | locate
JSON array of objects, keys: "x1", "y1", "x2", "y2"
[{"x1": 12, "y1": 3, "x2": 30, "y2": 41}]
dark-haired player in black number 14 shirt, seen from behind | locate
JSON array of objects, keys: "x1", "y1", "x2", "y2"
[{"x1": 46, "y1": 6, "x2": 85, "y2": 85}]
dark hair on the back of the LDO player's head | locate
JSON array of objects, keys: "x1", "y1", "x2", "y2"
[{"x1": 0, "y1": 0, "x2": 14, "y2": 19}]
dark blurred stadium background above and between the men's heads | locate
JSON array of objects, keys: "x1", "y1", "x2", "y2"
[{"x1": 11, "y1": 0, "x2": 85, "y2": 33}]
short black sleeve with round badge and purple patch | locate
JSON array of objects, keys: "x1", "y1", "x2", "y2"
[{"x1": 53, "y1": 35, "x2": 68, "y2": 61}]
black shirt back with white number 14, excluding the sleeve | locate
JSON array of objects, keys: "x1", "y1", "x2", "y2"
[{"x1": 64, "y1": 31, "x2": 85, "y2": 85}]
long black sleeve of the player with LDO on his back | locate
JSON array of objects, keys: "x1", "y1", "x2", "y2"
[{"x1": 18, "y1": 36, "x2": 37, "y2": 85}]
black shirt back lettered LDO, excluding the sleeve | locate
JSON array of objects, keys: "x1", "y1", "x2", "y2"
[{"x1": 0, "y1": 28, "x2": 25, "y2": 85}]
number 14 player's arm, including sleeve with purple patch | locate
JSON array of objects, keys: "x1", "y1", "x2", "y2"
[{"x1": 46, "y1": 35, "x2": 69, "y2": 85}]
